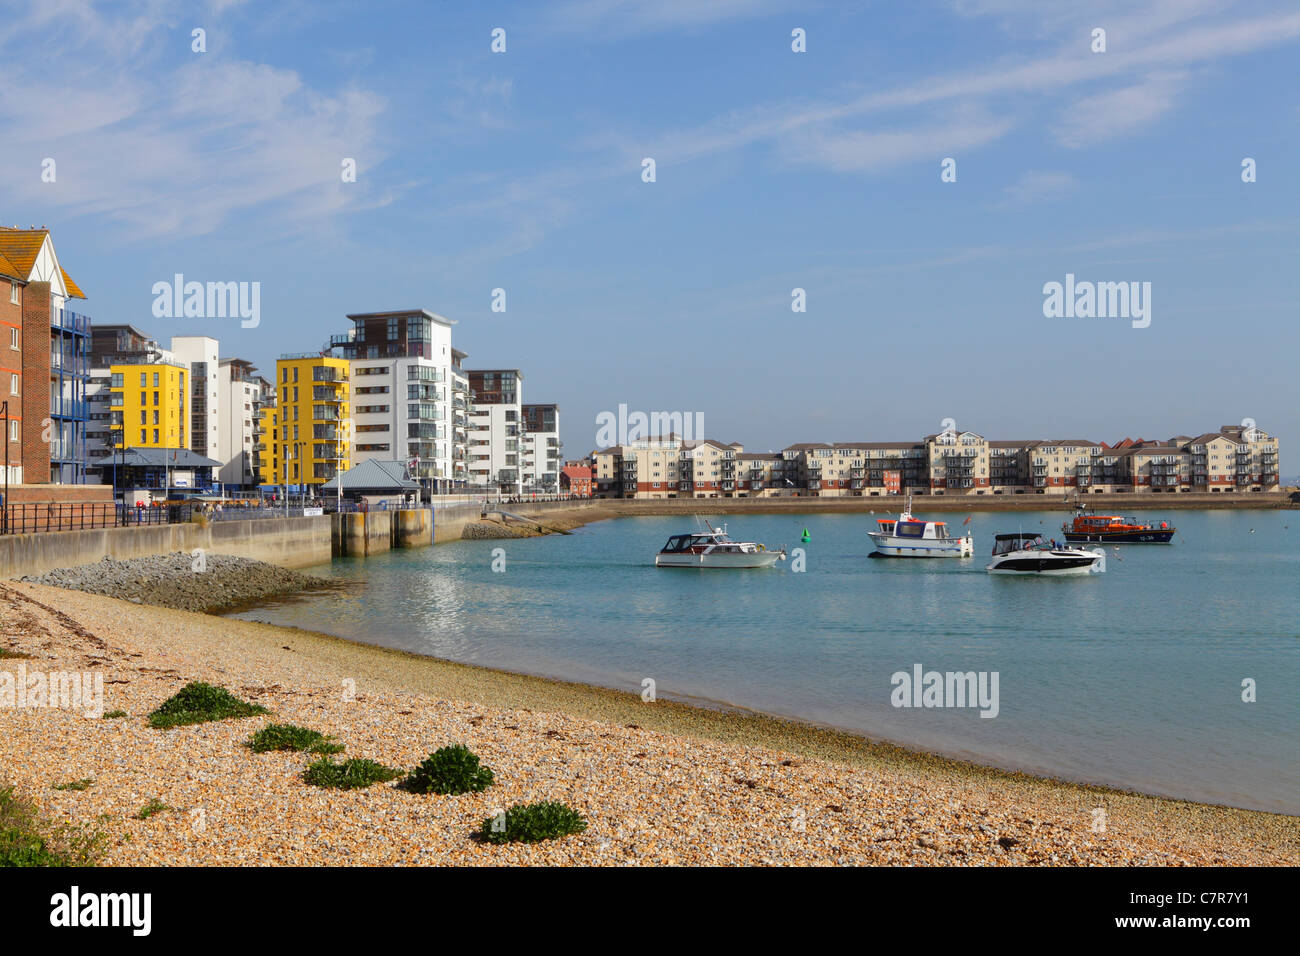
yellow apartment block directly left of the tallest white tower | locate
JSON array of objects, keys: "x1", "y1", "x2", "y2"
[{"x1": 261, "y1": 352, "x2": 352, "y2": 492}]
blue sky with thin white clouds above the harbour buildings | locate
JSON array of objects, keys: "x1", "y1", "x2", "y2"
[{"x1": 0, "y1": 0, "x2": 1300, "y2": 477}]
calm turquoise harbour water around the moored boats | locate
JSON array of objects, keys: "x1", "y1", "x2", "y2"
[{"x1": 228, "y1": 510, "x2": 1300, "y2": 813}]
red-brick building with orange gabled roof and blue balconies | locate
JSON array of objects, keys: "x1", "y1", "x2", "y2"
[{"x1": 0, "y1": 226, "x2": 91, "y2": 484}]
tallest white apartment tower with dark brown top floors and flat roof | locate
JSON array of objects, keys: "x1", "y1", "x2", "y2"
[{"x1": 330, "y1": 308, "x2": 464, "y2": 494}]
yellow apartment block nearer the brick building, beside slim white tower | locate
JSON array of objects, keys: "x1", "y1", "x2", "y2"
[{"x1": 109, "y1": 363, "x2": 190, "y2": 449}]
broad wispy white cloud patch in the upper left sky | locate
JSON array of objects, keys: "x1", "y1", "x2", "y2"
[{"x1": 0, "y1": 1, "x2": 385, "y2": 238}]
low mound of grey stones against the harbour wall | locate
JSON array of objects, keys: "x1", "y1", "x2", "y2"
[{"x1": 20, "y1": 551, "x2": 337, "y2": 611}]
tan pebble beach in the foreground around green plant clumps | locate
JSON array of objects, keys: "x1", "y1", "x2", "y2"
[{"x1": 0, "y1": 583, "x2": 1300, "y2": 866}]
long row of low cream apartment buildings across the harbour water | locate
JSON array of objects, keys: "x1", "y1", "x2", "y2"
[{"x1": 592, "y1": 425, "x2": 1281, "y2": 498}]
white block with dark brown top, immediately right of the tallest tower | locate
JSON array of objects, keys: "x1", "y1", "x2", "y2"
[{"x1": 465, "y1": 368, "x2": 524, "y2": 494}]
